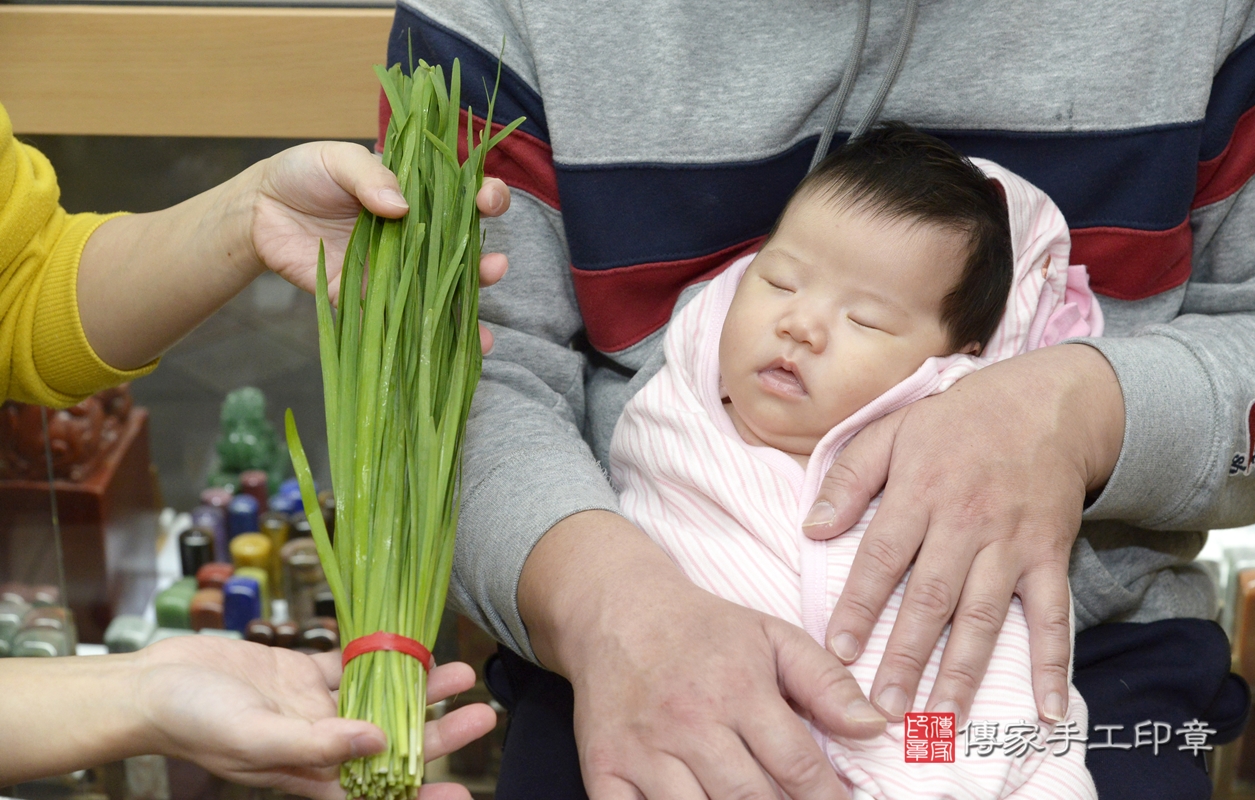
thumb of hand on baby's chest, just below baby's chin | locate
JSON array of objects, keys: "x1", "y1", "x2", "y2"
[{"x1": 802, "y1": 409, "x2": 905, "y2": 539}]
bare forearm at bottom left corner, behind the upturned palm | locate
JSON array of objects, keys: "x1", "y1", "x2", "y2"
[{"x1": 0, "y1": 656, "x2": 146, "y2": 786}]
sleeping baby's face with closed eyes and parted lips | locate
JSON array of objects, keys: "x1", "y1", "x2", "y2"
[{"x1": 719, "y1": 197, "x2": 966, "y2": 455}]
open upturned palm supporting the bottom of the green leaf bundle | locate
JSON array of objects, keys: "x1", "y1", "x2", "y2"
[{"x1": 133, "y1": 637, "x2": 497, "y2": 800}]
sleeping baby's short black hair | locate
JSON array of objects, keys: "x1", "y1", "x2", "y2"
[{"x1": 772, "y1": 122, "x2": 1014, "y2": 352}]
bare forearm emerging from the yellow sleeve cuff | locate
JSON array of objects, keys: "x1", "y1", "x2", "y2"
[{"x1": 78, "y1": 166, "x2": 265, "y2": 369}]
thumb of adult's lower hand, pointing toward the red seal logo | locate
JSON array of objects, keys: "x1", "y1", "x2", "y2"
[{"x1": 766, "y1": 619, "x2": 885, "y2": 738}]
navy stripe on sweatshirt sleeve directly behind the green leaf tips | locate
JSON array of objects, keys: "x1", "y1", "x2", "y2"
[{"x1": 388, "y1": 5, "x2": 548, "y2": 144}]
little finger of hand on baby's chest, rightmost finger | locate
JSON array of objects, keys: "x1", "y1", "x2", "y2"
[{"x1": 1019, "y1": 554, "x2": 1072, "y2": 722}]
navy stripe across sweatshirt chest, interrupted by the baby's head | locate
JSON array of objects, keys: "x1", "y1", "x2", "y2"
[{"x1": 556, "y1": 123, "x2": 1201, "y2": 270}]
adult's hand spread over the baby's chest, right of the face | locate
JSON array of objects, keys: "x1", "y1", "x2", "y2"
[{"x1": 804, "y1": 344, "x2": 1124, "y2": 721}]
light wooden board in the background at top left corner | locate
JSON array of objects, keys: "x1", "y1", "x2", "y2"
[{"x1": 0, "y1": 0, "x2": 393, "y2": 139}]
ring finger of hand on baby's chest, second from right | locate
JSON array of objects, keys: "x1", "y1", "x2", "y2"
[{"x1": 927, "y1": 548, "x2": 1015, "y2": 726}]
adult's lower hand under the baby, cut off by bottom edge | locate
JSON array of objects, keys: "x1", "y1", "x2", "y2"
[{"x1": 520, "y1": 511, "x2": 885, "y2": 800}]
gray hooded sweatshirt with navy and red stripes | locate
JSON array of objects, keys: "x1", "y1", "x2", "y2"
[{"x1": 389, "y1": 0, "x2": 1255, "y2": 658}]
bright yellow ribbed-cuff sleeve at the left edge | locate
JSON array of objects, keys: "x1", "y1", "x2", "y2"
[{"x1": 0, "y1": 105, "x2": 157, "y2": 407}]
